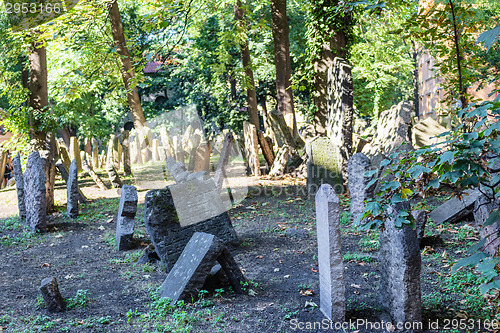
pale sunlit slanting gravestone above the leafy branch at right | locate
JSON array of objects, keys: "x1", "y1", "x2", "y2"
[{"x1": 362, "y1": 101, "x2": 413, "y2": 168}]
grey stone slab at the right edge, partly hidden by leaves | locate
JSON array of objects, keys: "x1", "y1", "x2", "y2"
[{"x1": 473, "y1": 194, "x2": 500, "y2": 256}]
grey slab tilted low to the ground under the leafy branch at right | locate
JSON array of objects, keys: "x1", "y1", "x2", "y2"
[{"x1": 429, "y1": 190, "x2": 481, "y2": 224}]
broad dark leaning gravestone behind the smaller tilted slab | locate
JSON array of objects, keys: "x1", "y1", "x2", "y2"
[{"x1": 144, "y1": 180, "x2": 239, "y2": 270}]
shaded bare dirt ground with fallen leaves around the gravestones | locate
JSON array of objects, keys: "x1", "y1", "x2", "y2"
[{"x1": 0, "y1": 172, "x2": 492, "y2": 332}]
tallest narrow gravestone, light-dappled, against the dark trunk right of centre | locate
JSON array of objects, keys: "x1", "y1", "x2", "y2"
[{"x1": 326, "y1": 58, "x2": 354, "y2": 179}]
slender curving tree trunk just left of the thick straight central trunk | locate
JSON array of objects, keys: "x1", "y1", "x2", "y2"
[{"x1": 234, "y1": 0, "x2": 274, "y2": 166}]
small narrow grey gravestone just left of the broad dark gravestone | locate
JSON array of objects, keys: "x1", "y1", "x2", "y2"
[{"x1": 116, "y1": 185, "x2": 137, "y2": 251}]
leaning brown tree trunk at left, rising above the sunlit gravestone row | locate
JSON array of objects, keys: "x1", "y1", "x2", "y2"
[{"x1": 108, "y1": 0, "x2": 146, "y2": 131}]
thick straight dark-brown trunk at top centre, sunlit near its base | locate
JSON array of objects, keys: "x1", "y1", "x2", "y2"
[{"x1": 271, "y1": 0, "x2": 298, "y2": 137}]
